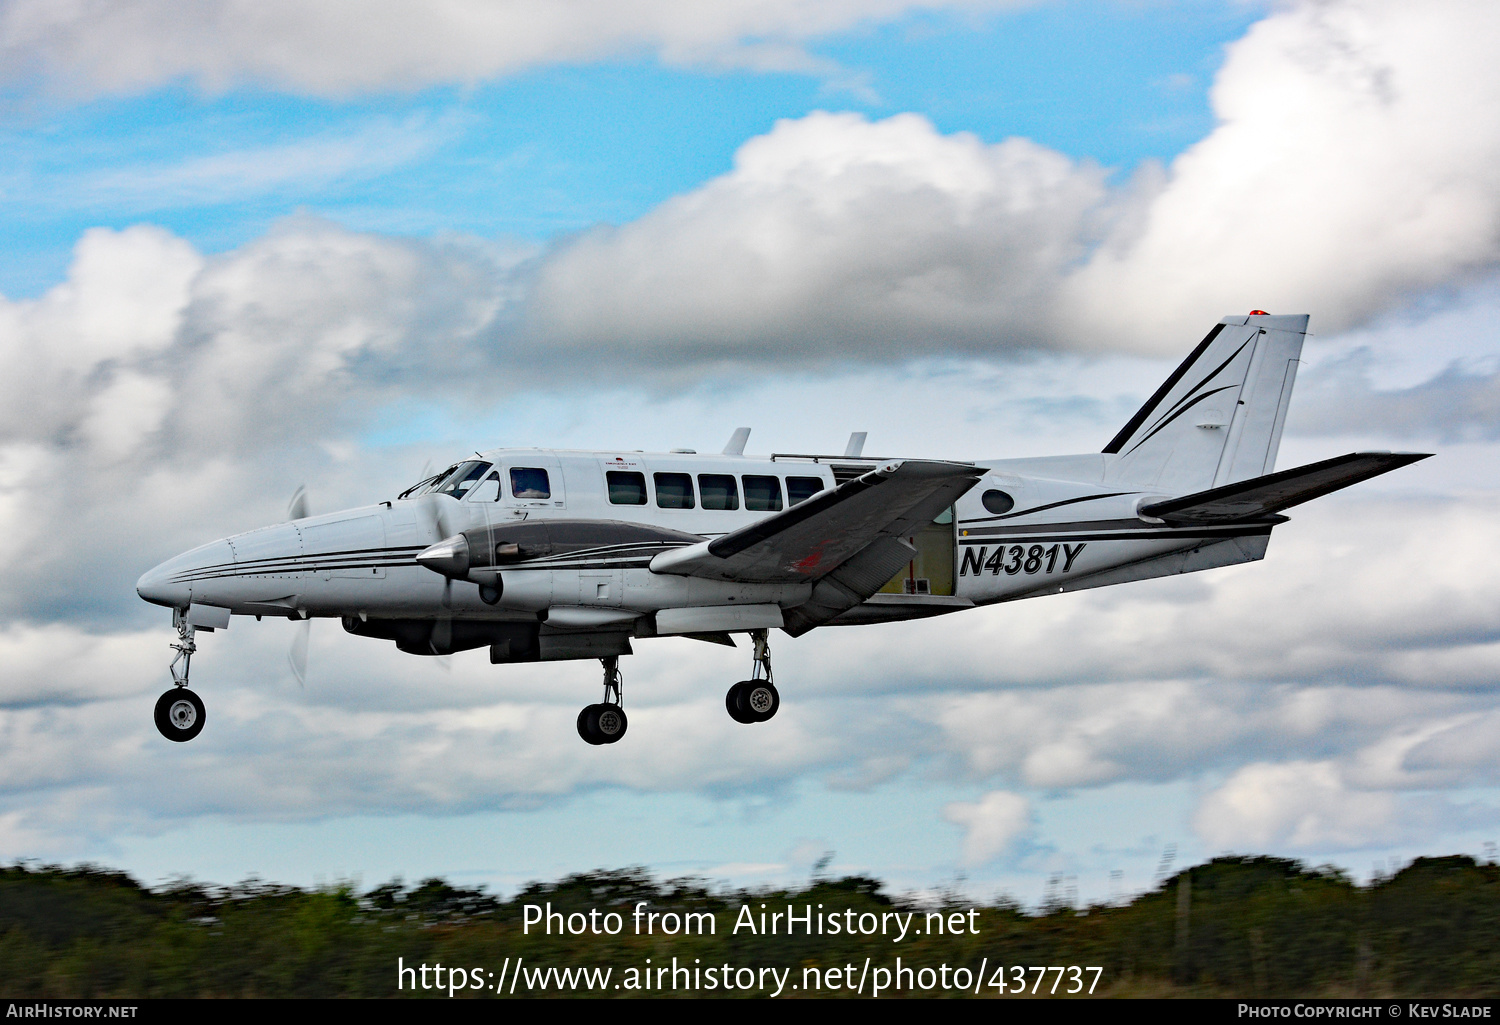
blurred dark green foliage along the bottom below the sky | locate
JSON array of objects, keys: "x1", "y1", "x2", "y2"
[{"x1": 0, "y1": 857, "x2": 1500, "y2": 998}]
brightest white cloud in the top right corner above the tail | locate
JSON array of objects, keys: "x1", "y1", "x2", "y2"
[{"x1": 1065, "y1": 0, "x2": 1500, "y2": 345}]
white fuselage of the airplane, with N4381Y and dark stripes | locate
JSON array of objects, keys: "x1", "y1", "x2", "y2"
[{"x1": 137, "y1": 449, "x2": 1271, "y2": 653}]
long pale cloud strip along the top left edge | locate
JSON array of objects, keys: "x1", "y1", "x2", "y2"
[{"x1": 0, "y1": 0, "x2": 1010, "y2": 98}]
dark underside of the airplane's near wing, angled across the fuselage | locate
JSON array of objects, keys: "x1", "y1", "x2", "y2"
[{"x1": 651, "y1": 459, "x2": 984, "y2": 585}]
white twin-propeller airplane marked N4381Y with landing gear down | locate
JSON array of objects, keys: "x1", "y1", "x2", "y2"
[{"x1": 135, "y1": 311, "x2": 1431, "y2": 744}]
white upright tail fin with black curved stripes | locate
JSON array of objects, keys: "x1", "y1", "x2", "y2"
[{"x1": 1104, "y1": 314, "x2": 1308, "y2": 494}]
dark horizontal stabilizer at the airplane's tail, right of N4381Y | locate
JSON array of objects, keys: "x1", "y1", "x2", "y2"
[{"x1": 1140, "y1": 452, "x2": 1433, "y2": 527}]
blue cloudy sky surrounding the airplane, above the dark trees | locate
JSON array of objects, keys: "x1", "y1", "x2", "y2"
[{"x1": 0, "y1": 0, "x2": 1500, "y2": 903}]
